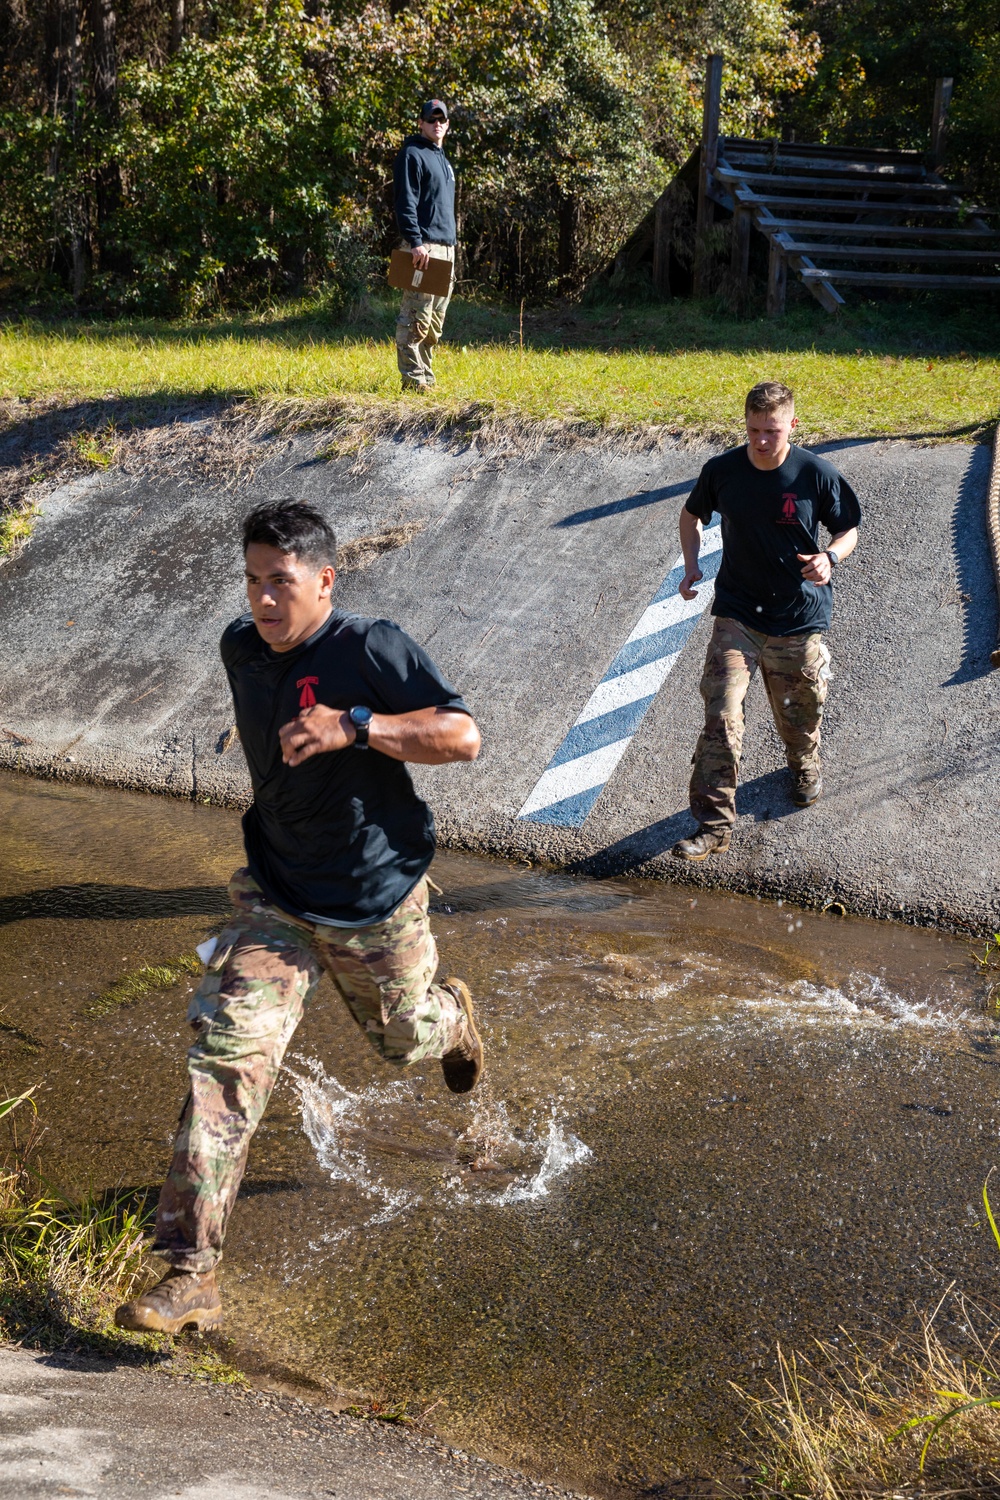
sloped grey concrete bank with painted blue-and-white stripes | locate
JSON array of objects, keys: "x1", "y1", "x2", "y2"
[{"x1": 0, "y1": 405, "x2": 1000, "y2": 932}]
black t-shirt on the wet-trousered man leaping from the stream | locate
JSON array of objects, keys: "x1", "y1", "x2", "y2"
[{"x1": 220, "y1": 611, "x2": 468, "y2": 927}]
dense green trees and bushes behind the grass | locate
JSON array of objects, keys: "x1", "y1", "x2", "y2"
[{"x1": 0, "y1": 0, "x2": 1000, "y2": 315}]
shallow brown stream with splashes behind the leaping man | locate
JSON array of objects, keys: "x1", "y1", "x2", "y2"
[{"x1": 0, "y1": 776, "x2": 1000, "y2": 1494}]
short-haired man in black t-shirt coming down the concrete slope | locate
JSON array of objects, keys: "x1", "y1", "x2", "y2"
[{"x1": 673, "y1": 381, "x2": 861, "y2": 860}]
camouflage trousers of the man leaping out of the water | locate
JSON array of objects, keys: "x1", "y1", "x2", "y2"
[{"x1": 153, "y1": 870, "x2": 462, "y2": 1271}]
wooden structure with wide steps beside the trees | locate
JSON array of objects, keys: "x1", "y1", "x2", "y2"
[{"x1": 616, "y1": 54, "x2": 1000, "y2": 317}]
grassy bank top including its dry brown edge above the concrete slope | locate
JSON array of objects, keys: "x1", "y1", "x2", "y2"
[{"x1": 0, "y1": 297, "x2": 1000, "y2": 558}]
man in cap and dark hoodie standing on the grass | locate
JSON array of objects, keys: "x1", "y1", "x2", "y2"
[{"x1": 393, "y1": 99, "x2": 456, "y2": 390}]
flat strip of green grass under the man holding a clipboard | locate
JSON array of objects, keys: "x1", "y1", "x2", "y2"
[{"x1": 0, "y1": 299, "x2": 1000, "y2": 441}]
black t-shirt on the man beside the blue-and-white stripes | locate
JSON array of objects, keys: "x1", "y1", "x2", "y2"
[{"x1": 687, "y1": 444, "x2": 861, "y2": 636}]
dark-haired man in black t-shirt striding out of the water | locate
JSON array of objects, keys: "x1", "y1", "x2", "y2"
[{"x1": 115, "y1": 501, "x2": 483, "y2": 1334}]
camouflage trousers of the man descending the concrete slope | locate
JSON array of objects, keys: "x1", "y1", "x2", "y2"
[{"x1": 691, "y1": 617, "x2": 831, "y2": 828}]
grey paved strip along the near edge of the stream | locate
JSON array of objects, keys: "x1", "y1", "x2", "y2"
[{"x1": 0, "y1": 1349, "x2": 587, "y2": 1500}]
